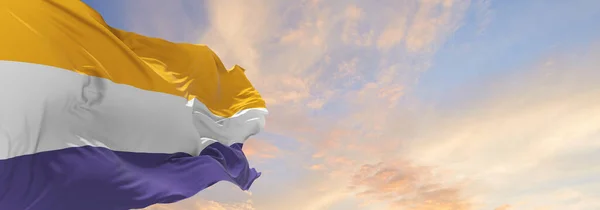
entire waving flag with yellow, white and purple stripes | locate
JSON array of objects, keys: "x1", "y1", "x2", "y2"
[{"x1": 0, "y1": 0, "x2": 267, "y2": 210}]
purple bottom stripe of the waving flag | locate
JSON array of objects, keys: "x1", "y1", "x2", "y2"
[{"x1": 0, "y1": 143, "x2": 260, "y2": 210}]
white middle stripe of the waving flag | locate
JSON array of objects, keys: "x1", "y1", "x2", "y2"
[{"x1": 0, "y1": 61, "x2": 267, "y2": 159}]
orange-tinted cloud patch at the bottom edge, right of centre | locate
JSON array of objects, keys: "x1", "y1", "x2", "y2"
[{"x1": 350, "y1": 161, "x2": 471, "y2": 210}]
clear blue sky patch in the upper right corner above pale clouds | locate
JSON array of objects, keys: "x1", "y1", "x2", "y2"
[{"x1": 419, "y1": 1, "x2": 600, "y2": 104}]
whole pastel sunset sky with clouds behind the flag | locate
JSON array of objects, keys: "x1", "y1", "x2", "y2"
[{"x1": 84, "y1": 0, "x2": 600, "y2": 210}]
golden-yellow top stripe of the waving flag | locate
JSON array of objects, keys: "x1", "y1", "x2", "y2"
[{"x1": 0, "y1": 0, "x2": 265, "y2": 117}]
